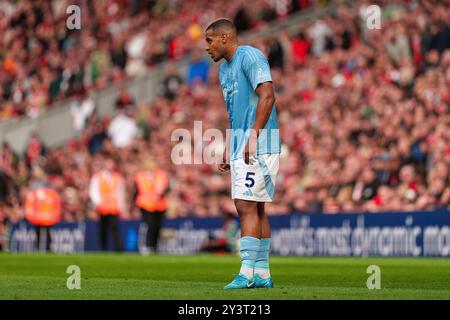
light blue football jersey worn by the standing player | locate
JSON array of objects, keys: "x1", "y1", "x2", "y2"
[{"x1": 219, "y1": 46, "x2": 281, "y2": 160}]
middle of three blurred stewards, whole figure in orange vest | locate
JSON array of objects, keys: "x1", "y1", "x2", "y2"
[{"x1": 89, "y1": 155, "x2": 127, "y2": 251}]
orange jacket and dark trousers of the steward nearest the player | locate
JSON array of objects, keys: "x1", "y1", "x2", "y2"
[{"x1": 134, "y1": 168, "x2": 169, "y2": 254}]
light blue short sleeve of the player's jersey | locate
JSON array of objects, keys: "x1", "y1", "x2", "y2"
[{"x1": 242, "y1": 50, "x2": 272, "y2": 90}]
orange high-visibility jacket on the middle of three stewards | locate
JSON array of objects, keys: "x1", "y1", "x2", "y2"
[{"x1": 93, "y1": 171, "x2": 124, "y2": 215}]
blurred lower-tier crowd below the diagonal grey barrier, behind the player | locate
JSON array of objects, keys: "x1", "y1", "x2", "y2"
[{"x1": 0, "y1": 1, "x2": 450, "y2": 225}]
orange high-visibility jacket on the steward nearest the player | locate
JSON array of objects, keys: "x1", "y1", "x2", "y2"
[{"x1": 134, "y1": 169, "x2": 169, "y2": 211}]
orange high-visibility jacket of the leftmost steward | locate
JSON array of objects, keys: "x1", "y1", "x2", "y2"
[{"x1": 25, "y1": 188, "x2": 61, "y2": 227}]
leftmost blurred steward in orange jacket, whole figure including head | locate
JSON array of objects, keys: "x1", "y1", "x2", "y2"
[{"x1": 25, "y1": 167, "x2": 61, "y2": 252}]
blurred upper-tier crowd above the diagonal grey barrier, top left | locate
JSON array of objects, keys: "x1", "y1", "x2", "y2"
[{"x1": 0, "y1": 0, "x2": 309, "y2": 121}]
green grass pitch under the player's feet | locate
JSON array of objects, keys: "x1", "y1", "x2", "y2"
[{"x1": 0, "y1": 253, "x2": 450, "y2": 300}]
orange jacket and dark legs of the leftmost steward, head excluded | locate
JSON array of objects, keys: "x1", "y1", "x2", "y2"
[{"x1": 25, "y1": 187, "x2": 61, "y2": 251}]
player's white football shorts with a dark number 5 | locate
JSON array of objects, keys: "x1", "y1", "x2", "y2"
[{"x1": 230, "y1": 153, "x2": 280, "y2": 202}]
